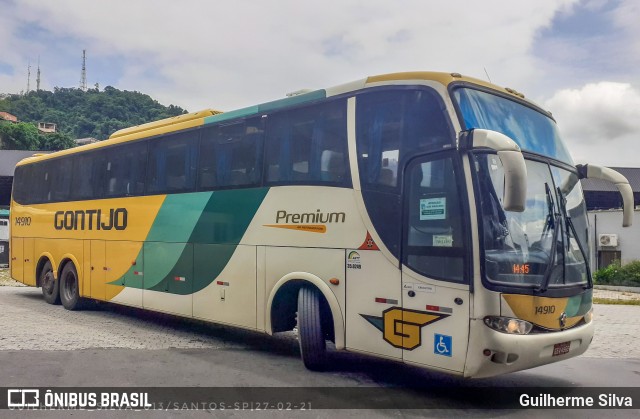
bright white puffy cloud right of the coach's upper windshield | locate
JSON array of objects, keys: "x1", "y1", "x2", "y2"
[{"x1": 545, "y1": 81, "x2": 640, "y2": 166}]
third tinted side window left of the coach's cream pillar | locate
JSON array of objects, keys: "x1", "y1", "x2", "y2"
[{"x1": 147, "y1": 131, "x2": 199, "y2": 194}]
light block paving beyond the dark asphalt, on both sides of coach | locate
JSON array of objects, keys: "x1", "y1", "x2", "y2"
[{"x1": 0, "y1": 287, "x2": 640, "y2": 359}]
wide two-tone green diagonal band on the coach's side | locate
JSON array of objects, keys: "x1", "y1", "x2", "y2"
[{"x1": 111, "y1": 188, "x2": 269, "y2": 295}]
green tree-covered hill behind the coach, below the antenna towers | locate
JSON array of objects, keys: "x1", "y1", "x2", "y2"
[{"x1": 0, "y1": 86, "x2": 186, "y2": 150}]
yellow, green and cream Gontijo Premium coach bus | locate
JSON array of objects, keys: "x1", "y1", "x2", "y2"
[{"x1": 11, "y1": 72, "x2": 633, "y2": 377}]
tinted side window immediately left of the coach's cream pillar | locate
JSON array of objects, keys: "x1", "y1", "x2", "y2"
[{"x1": 265, "y1": 100, "x2": 349, "y2": 185}]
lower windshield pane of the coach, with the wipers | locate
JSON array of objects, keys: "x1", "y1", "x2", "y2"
[{"x1": 474, "y1": 154, "x2": 588, "y2": 291}]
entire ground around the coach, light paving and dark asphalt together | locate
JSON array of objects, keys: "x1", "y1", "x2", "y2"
[{"x1": 0, "y1": 287, "x2": 640, "y2": 418}]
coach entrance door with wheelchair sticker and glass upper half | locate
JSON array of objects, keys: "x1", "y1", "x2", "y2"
[{"x1": 394, "y1": 153, "x2": 471, "y2": 372}]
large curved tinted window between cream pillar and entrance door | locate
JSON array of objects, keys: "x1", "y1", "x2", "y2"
[{"x1": 356, "y1": 88, "x2": 455, "y2": 257}]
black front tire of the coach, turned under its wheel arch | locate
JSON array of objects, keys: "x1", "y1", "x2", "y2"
[{"x1": 298, "y1": 287, "x2": 327, "y2": 371}]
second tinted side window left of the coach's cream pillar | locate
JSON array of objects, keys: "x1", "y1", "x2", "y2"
[{"x1": 198, "y1": 118, "x2": 263, "y2": 190}]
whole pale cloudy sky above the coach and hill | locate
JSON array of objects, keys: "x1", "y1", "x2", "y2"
[{"x1": 0, "y1": 0, "x2": 640, "y2": 167}]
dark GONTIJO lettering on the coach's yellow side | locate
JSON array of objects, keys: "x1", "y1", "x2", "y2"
[{"x1": 53, "y1": 208, "x2": 128, "y2": 230}]
